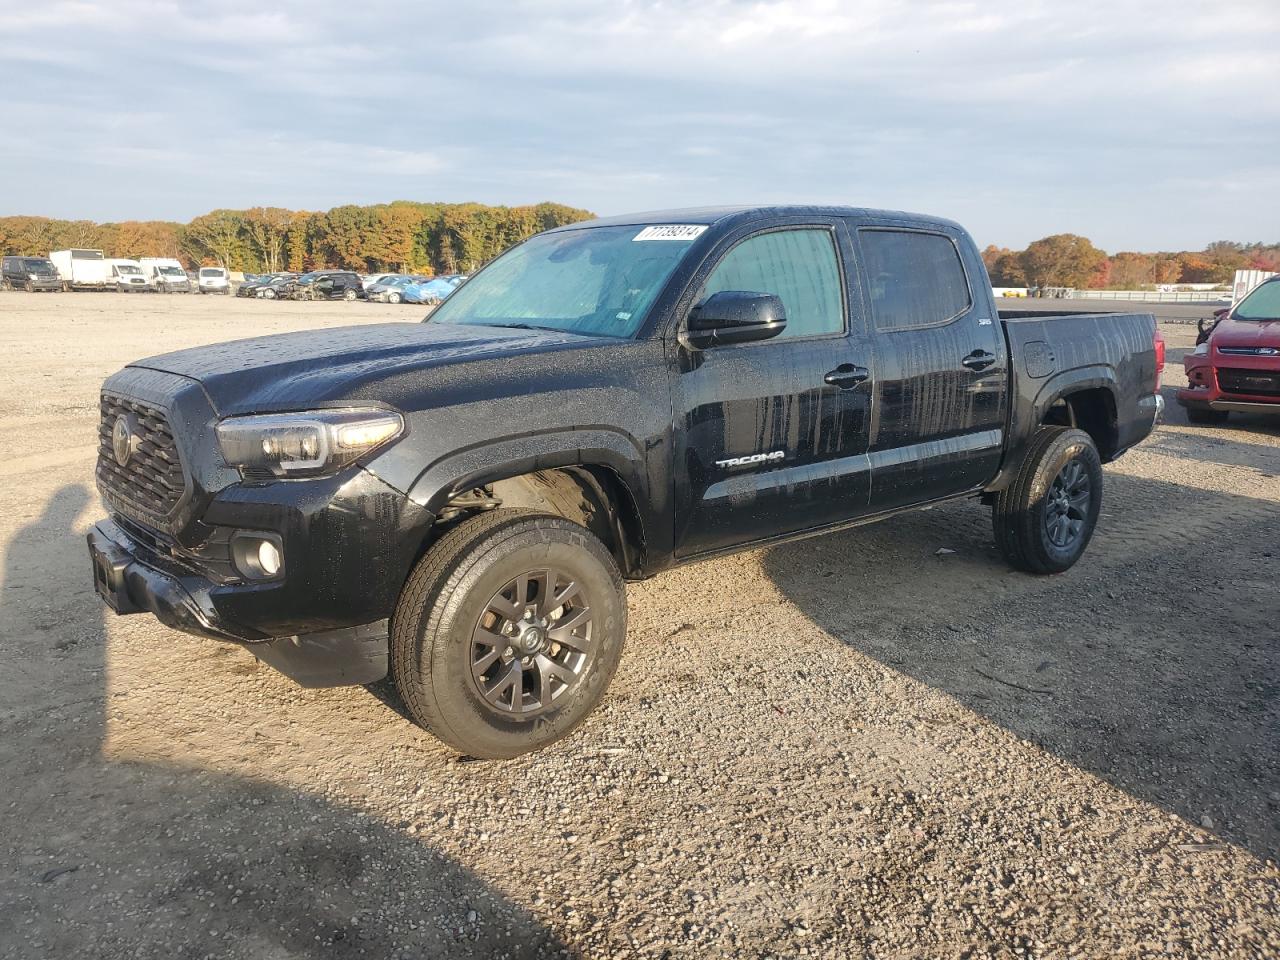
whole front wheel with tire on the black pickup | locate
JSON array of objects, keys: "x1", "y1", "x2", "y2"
[{"x1": 390, "y1": 509, "x2": 627, "y2": 758}]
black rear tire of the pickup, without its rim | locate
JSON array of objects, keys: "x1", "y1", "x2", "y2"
[{"x1": 992, "y1": 426, "x2": 1102, "y2": 573}]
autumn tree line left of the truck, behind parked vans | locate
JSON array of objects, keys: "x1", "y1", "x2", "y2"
[{"x1": 0, "y1": 200, "x2": 593, "y2": 274}]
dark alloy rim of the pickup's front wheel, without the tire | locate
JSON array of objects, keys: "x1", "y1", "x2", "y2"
[{"x1": 471, "y1": 570, "x2": 595, "y2": 719}]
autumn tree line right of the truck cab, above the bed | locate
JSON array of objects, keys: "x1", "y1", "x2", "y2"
[{"x1": 982, "y1": 233, "x2": 1280, "y2": 291}]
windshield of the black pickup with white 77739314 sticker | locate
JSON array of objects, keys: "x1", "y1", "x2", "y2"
[{"x1": 430, "y1": 225, "x2": 705, "y2": 337}]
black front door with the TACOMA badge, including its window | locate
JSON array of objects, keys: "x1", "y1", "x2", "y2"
[{"x1": 668, "y1": 220, "x2": 872, "y2": 557}]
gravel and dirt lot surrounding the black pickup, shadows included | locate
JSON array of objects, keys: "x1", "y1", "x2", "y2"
[{"x1": 0, "y1": 293, "x2": 1280, "y2": 960}]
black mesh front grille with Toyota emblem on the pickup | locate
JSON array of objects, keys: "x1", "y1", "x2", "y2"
[{"x1": 97, "y1": 393, "x2": 186, "y2": 517}]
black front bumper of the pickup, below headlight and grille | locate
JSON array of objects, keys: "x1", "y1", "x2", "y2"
[{"x1": 88, "y1": 455, "x2": 434, "y2": 686}]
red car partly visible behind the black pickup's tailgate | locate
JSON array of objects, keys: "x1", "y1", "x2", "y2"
[{"x1": 1178, "y1": 276, "x2": 1280, "y2": 424}]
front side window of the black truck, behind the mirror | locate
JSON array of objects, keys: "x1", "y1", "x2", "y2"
[{"x1": 703, "y1": 229, "x2": 845, "y2": 337}]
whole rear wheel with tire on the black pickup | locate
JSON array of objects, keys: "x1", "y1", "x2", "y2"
[{"x1": 992, "y1": 426, "x2": 1102, "y2": 573}]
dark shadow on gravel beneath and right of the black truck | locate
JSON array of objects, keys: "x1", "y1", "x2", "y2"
[{"x1": 765, "y1": 471, "x2": 1280, "y2": 858}]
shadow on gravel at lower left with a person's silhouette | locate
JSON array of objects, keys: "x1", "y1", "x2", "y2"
[{"x1": 0, "y1": 485, "x2": 576, "y2": 960}]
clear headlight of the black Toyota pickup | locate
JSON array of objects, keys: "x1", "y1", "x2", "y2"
[{"x1": 218, "y1": 408, "x2": 404, "y2": 477}]
